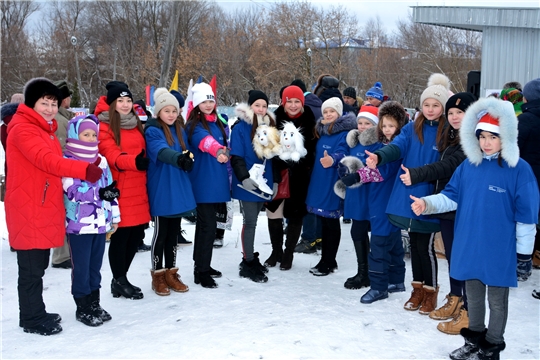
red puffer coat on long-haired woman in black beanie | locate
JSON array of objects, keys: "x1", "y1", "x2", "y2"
[{"x1": 99, "y1": 98, "x2": 150, "y2": 227}]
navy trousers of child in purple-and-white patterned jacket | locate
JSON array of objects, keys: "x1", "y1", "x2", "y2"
[{"x1": 68, "y1": 234, "x2": 105, "y2": 299}]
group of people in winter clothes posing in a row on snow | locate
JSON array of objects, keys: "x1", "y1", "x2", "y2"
[{"x1": 2, "y1": 74, "x2": 540, "y2": 359}]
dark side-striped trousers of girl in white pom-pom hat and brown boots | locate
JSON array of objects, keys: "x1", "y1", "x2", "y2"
[{"x1": 409, "y1": 232, "x2": 438, "y2": 287}]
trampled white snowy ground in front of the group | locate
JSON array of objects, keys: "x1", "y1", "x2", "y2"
[{"x1": 0, "y1": 206, "x2": 540, "y2": 359}]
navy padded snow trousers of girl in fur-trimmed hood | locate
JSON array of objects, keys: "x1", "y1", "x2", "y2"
[{"x1": 368, "y1": 231, "x2": 405, "y2": 291}]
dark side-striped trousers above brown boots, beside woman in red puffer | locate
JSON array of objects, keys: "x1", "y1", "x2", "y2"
[{"x1": 151, "y1": 216, "x2": 182, "y2": 270}]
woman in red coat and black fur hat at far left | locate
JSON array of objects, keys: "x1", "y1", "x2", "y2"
[{"x1": 5, "y1": 78, "x2": 102, "y2": 335}]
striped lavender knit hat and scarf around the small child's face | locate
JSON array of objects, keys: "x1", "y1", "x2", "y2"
[{"x1": 64, "y1": 115, "x2": 99, "y2": 163}]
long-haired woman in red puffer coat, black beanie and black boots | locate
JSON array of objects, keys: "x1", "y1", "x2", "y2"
[{"x1": 95, "y1": 81, "x2": 150, "y2": 299}]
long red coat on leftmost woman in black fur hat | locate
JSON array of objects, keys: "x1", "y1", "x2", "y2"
[{"x1": 5, "y1": 104, "x2": 88, "y2": 250}]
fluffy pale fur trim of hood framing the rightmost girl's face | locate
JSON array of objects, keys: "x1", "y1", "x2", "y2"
[{"x1": 459, "y1": 97, "x2": 519, "y2": 167}]
